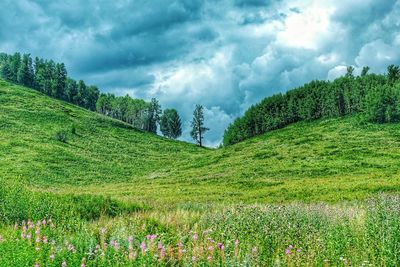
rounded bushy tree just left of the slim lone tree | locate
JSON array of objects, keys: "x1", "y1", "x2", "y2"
[{"x1": 160, "y1": 108, "x2": 182, "y2": 139}]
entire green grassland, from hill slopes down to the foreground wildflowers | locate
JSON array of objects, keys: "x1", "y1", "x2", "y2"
[{"x1": 0, "y1": 80, "x2": 400, "y2": 266}]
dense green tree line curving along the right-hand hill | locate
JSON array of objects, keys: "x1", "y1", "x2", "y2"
[{"x1": 223, "y1": 65, "x2": 400, "y2": 145}]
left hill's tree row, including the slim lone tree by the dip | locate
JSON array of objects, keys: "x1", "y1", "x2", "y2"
[{"x1": 0, "y1": 53, "x2": 208, "y2": 146}]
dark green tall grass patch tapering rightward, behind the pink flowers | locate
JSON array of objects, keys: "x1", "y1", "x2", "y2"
[{"x1": 0, "y1": 179, "x2": 144, "y2": 224}]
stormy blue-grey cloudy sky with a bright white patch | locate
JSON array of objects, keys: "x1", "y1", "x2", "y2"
[{"x1": 0, "y1": 0, "x2": 400, "y2": 146}]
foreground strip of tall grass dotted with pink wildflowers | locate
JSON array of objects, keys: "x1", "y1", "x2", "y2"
[{"x1": 0, "y1": 195, "x2": 400, "y2": 266}]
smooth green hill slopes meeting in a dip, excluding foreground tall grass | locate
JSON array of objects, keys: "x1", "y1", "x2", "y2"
[{"x1": 0, "y1": 81, "x2": 400, "y2": 205}]
